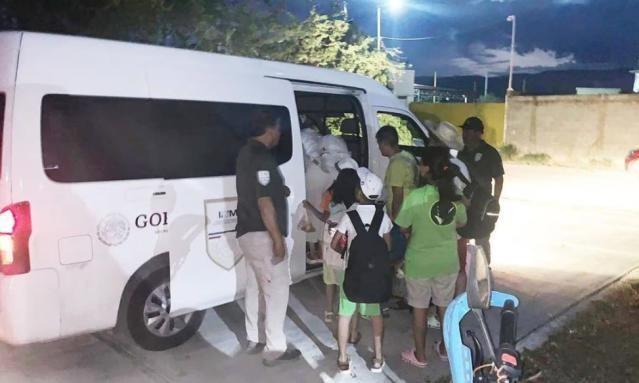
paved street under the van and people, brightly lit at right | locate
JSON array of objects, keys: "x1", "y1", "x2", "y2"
[{"x1": 0, "y1": 165, "x2": 639, "y2": 383}]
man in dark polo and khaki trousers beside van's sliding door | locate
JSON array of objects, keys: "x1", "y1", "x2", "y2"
[{"x1": 236, "y1": 110, "x2": 300, "y2": 367}]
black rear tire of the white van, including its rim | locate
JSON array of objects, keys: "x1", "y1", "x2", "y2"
[{"x1": 126, "y1": 270, "x2": 205, "y2": 351}]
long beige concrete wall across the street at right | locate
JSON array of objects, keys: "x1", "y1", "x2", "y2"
[{"x1": 506, "y1": 94, "x2": 639, "y2": 163}]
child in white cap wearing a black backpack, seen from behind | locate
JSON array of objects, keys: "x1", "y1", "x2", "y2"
[{"x1": 331, "y1": 168, "x2": 393, "y2": 373}]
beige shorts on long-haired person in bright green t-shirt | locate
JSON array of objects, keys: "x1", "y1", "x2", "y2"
[{"x1": 406, "y1": 273, "x2": 457, "y2": 309}]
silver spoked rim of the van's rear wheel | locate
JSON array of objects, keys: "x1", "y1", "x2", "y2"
[{"x1": 144, "y1": 283, "x2": 193, "y2": 337}]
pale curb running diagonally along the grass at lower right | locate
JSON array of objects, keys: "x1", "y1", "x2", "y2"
[{"x1": 517, "y1": 264, "x2": 639, "y2": 352}]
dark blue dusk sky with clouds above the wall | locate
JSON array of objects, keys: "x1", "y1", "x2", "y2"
[{"x1": 289, "y1": 0, "x2": 639, "y2": 76}]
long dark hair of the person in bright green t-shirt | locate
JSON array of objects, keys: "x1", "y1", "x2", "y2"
[{"x1": 422, "y1": 146, "x2": 461, "y2": 206}]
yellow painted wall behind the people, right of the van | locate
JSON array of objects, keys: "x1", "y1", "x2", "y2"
[{"x1": 410, "y1": 102, "x2": 504, "y2": 147}]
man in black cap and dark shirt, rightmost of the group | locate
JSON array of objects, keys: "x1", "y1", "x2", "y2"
[{"x1": 457, "y1": 117, "x2": 504, "y2": 263}]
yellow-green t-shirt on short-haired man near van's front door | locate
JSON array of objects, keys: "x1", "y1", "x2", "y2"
[{"x1": 384, "y1": 150, "x2": 417, "y2": 214}]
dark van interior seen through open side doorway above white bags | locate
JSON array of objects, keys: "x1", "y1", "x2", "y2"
[{"x1": 295, "y1": 92, "x2": 368, "y2": 166}]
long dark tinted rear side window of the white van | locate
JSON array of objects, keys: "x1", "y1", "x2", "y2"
[{"x1": 42, "y1": 94, "x2": 292, "y2": 182}]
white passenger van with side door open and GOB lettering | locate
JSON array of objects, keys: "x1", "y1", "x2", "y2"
[{"x1": 0, "y1": 32, "x2": 428, "y2": 350}]
